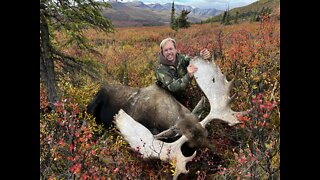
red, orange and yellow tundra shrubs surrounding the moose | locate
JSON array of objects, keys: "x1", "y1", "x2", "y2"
[{"x1": 40, "y1": 14, "x2": 280, "y2": 179}]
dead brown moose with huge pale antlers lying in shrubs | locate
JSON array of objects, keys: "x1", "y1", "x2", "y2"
[{"x1": 87, "y1": 56, "x2": 247, "y2": 179}]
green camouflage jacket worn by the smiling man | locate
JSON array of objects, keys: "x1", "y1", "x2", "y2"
[{"x1": 156, "y1": 53, "x2": 191, "y2": 94}]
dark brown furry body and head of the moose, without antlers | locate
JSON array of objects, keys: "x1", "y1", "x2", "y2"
[{"x1": 87, "y1": 84, "x2": 208, "y2": 147}]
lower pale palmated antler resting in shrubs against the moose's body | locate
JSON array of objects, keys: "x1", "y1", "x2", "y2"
[{"x1": 115, "y1": 109, "x2": 196, "y2": 179}]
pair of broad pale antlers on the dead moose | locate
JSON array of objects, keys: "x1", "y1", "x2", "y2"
[{"x1": 115, "y1": 57, "x2": 245, "y2": 179}]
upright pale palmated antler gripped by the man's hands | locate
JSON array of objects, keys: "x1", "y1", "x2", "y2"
[{"x1": 190, "y1": 57, "x2": 246, "y2": 127}]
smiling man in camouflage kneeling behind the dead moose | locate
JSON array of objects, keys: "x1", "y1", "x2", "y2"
[{"x1": 155, "y1": 38, "x2": 211, "y2": 104}]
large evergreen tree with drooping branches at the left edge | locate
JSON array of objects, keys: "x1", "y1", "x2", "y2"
[{"x1": 40, "y1": 0, "x2": 114, "y2": 107}]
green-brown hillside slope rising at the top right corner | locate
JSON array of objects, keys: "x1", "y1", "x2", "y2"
[{"x1": 203, "y1": 0, "x2": 280, "y2": 23}]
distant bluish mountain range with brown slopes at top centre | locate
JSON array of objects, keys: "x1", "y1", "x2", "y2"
[{"x1": 103, "y1": 1, "x2": 223, "y2": 27}]
